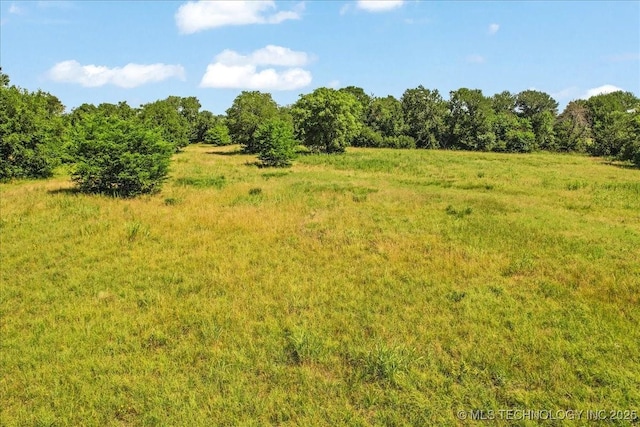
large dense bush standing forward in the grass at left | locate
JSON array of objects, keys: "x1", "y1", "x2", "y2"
[{"x1": 70, "y1": 116, "x2": 174, "y2": 197}]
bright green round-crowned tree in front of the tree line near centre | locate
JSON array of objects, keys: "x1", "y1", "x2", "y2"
[{"x1": 291, "y1": 87, "x2": 362, "y2": 153}]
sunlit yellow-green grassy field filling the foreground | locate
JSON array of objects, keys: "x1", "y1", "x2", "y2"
[{"x1": 0, "y1": 145, "x2": 640, "y2": 426}]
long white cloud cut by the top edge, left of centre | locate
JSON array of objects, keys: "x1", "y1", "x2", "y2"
[{"x1": 175, "y1": 0, "x2": 304, "y2": 34}]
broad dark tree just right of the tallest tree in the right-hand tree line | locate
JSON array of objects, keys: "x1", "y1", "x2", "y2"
[{"x1": 447, "y1": 88, "x2": 495, "y2": 151}]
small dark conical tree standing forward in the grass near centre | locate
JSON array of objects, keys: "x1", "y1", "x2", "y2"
[{"x1": 255, "y1": 118, "x2": 297, "y2": 167}]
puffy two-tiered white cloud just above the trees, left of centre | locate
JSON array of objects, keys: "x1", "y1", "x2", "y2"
[{"x1": 200, "y1": 45, "x2": 312, "y2": 90}]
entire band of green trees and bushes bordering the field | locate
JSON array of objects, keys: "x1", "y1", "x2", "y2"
[{"x1": 0, "y1": 72, "x2": 640, "y2": 196}]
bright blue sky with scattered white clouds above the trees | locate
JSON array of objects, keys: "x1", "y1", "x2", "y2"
[{"x1": 0, "y1": 0, "x2": 640, "y2": 114}]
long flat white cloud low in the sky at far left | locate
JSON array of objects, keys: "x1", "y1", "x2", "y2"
[{"x1": 48, "y1": 60, "x2": 185, "y2": 88}]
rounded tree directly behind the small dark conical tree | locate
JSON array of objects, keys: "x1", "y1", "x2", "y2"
[{"x1": 227, "y1": 91, "x2": 279, "y2": 154}]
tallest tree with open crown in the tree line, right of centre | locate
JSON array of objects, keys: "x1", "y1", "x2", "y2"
[{"x1": 400, "y1": 85, "x2": 447, "y2": 148}]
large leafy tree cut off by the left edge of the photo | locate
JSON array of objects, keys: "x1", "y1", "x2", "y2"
[{"x1": 0, "y1": 79, "x2": 65, "y2": 179}]
